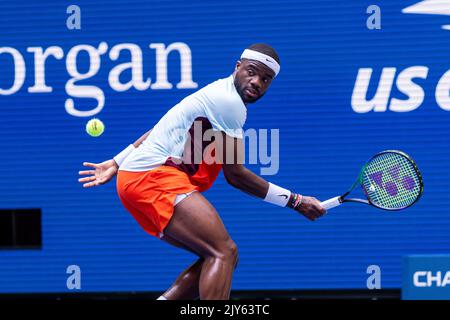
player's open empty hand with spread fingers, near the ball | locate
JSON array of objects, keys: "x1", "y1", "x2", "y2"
[{"x1": 78, "y1": 159, "x2": 119, "y2": 188}]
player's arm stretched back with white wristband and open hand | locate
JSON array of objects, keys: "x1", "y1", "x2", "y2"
[{"x1": 78, "y1": 129, "x2": 153, "y2": 188}]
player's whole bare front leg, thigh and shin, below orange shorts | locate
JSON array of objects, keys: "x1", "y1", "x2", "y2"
[{"x1": 164, "y1": 192, "x2": 237, "y2": 299}]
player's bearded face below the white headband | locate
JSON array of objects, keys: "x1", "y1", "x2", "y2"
[{"x1": 234, "y1": 59, "x2": 275, "y2": 103}]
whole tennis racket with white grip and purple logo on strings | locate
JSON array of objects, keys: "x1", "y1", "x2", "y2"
[{"x1": 321, "y1": 150, "x2": 423, "y2": 211}]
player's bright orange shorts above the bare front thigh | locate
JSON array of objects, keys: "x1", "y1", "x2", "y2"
[{"x1": 117, "y1": 166, "x2": 199, "y2": 238}]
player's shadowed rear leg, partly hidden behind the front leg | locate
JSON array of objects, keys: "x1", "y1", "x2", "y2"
[{"x1": 161, "y1": 235, "x2": 204, "y2": 300}]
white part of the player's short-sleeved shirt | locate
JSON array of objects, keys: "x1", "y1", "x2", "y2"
[{"x1": 119, "y1": 75, "x2": 247, "y2": 171}]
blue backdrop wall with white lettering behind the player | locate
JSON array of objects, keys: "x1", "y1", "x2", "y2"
[{"x1": 0, "y1": 0, "x2": 450, "y2": 292}]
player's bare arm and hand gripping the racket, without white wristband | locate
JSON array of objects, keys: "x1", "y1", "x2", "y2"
[{"x1": 217, "y1": 132, "x2": 326, "y2": 221}]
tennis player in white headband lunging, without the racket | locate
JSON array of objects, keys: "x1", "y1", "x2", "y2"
[{"x1": 79, "y1": 44, "x2": 325, "y2": 300}]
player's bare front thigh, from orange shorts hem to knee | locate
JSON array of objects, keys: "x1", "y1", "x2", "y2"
[{"x1": 164, "y1": 192, "x2": 236, "y2": 257}]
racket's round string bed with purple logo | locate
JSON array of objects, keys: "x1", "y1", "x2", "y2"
[{"x1": 361, "y1": 152, "x2": 422, "y2": 209}]
